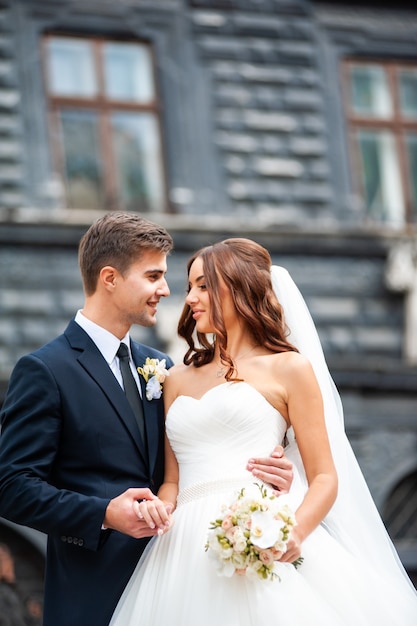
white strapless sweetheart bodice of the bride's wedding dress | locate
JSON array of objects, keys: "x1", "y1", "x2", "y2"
[{"x1": 166, "y1": 382, "x2": 287, "y2": 490}]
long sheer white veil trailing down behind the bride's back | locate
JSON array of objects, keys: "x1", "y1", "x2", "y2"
[{"x1": 271, "y1": 266, "x2": 417, "y2": 596}]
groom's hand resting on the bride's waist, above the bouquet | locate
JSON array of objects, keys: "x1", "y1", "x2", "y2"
[{"x1": 246, "y1": 446, "x2": 293, "y2": 495}]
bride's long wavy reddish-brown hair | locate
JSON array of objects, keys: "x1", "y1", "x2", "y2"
[{"x1": 178, "y1": 238, "x2": 298, "y2": 380}]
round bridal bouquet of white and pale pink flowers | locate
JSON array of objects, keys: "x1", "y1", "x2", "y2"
[{"x1": 206, "y1": 483, "x2": 302, "y2": 580}]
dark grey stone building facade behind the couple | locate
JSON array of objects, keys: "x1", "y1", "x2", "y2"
[{"x1": 0, "y1": 0, "x2": 417, "y2": 608}]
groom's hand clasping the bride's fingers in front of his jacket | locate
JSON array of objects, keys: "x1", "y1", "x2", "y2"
[{"x1": 103, "y1": 488, "x2": 162, "y2": 539}]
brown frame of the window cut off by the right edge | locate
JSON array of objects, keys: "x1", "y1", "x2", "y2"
[{"x1": 341, "y1": 56, "x2": 417, "y2": 226}]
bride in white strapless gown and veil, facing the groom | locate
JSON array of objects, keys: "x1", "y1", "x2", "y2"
[{"x1": 111, "y1": 238, "x2": 417, "y2": 626}]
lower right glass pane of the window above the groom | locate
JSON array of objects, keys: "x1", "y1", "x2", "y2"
[{"x1": 111, "y1": 113, "x2": 164, "y2": 211}]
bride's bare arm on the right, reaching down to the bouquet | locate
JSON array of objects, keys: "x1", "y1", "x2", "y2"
[{"x1": 282, "y1": 353, "x2": 337, "y2": 562}]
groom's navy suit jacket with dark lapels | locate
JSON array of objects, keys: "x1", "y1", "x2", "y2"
[{"x1": 0, "y1": 320, "x2": 172, "y2": 626}]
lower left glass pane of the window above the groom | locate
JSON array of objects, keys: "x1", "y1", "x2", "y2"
[{"x1": 60, "y1": 109, "x2": 105, "y2": 209}]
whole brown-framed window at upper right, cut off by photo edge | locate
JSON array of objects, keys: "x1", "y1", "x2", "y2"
[{"x1": 343, "y1": 60, "x2": 417, "y2": 226}]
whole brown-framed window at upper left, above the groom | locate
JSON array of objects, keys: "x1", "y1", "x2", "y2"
[{"x1": 43, "y1": 35, "x2": 166, "y2": 212}]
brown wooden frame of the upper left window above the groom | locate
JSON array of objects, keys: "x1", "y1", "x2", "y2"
[{"x1": 40, "y1": 31, "x2": 170, "y2": 213}]
